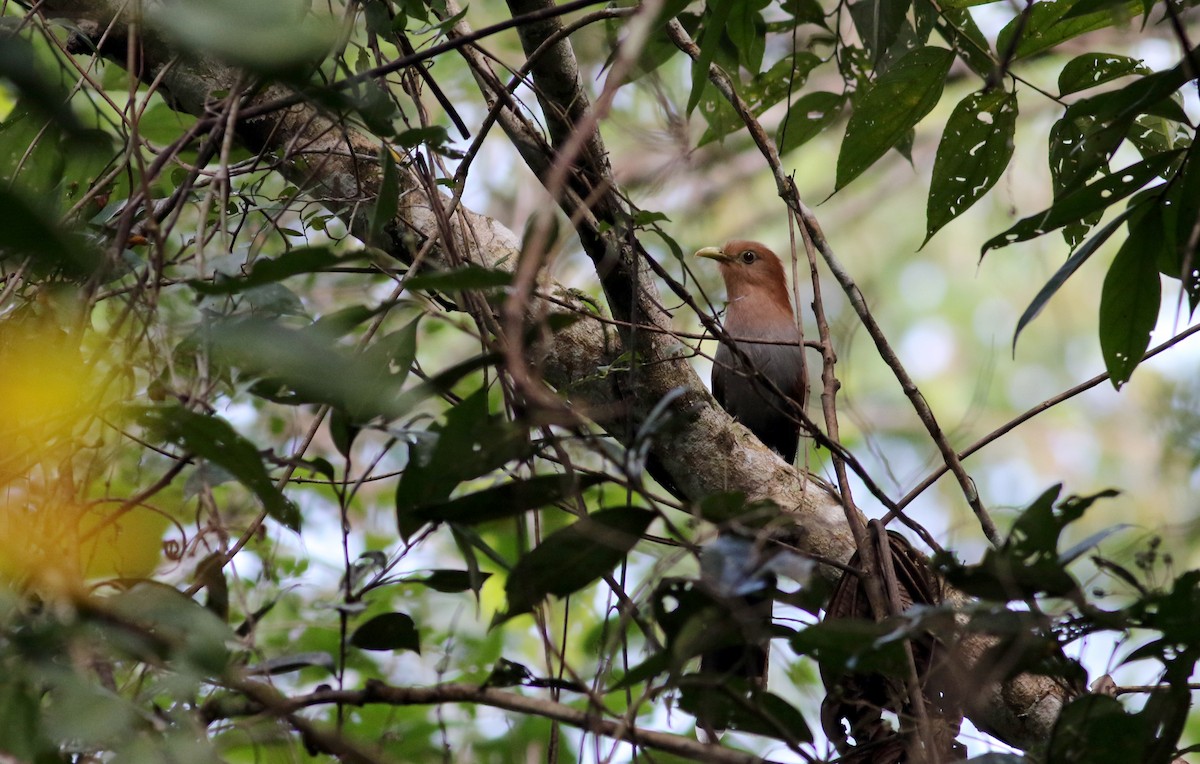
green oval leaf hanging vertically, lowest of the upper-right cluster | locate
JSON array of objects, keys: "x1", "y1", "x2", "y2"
[{"x1": 1100, "y1": 231, "x2": 1162, "y2": 390}]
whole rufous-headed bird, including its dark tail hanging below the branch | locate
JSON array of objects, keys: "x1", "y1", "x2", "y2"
[{"x1": 696, "y1": 241, "x2": 808, "y2": 686}]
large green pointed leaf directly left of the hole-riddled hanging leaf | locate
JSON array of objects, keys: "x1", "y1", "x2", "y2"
[{"x1": 835, "y1": 47, "x2": 954, "y2": 191}]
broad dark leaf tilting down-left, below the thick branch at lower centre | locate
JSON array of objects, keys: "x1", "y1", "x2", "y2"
[{"x1": 503, "y1": 506, "x2": 658, "y2": 619}]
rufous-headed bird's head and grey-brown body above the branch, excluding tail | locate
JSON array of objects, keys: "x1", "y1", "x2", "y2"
[{"x1": 696, "y1": 241, "x2": 809, "y2": 464}]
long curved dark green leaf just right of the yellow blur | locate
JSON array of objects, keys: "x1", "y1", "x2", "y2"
[{"x1": 134, "y1": 405, "x2": 300, "y2": 533}]
